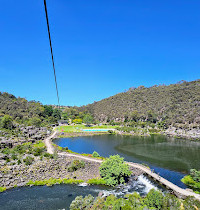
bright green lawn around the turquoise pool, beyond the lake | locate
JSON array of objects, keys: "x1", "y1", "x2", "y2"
[{"x1": 56, "y1": 124, "x2": 118, "y2": 133}]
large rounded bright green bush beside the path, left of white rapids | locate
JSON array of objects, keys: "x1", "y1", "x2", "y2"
[{"x1": 100, "y1": 155, "x2": 131, "y2": 186}]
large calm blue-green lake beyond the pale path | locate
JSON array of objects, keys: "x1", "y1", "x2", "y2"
[{"x1": 54, "y1": 135, "x2": 200, "y2": 188}]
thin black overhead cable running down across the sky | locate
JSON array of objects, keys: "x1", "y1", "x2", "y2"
[{"x1": 44, "y1": 0, "x2": 60, "y2": 108}]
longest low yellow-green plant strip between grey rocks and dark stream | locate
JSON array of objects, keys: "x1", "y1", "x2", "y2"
[{"x1": 26, "y1": 178, "x2": 84, "y2": 186}]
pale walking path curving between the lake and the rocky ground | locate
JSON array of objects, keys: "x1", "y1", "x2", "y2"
[{"x1": 45, "y1": 131, "x2": 200, "y2": 201}]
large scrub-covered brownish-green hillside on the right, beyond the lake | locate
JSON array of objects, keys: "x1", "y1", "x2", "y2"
[{"x1": 80, "y1": 80, "x2": 200, "y2": 128}]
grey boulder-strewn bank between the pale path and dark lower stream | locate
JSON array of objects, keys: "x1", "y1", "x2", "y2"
[{"x1": 0, "y1": 154, "x2": 100, "y2": 189}]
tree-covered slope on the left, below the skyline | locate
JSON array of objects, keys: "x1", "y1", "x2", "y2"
[{"x1": 0, "y1": 92, "x2": 61, "y2": 126}]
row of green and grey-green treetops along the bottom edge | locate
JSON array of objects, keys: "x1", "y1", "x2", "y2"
[{"x1": 70, "y1": 189, "x2": 200, "y2": 210}]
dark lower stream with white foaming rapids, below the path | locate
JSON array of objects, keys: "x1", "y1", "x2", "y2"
[{"x1": 0, "y1": 175, "x2": 163, "y2": 210}]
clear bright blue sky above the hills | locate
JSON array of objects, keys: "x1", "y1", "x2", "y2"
[{"x1": 0, "y1": 0, "x2": 200, "y2": 105}]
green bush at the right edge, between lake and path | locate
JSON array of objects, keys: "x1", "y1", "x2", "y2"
[{"x1": 181, "y1": 169, "x2": 200, "y2": 193}]
